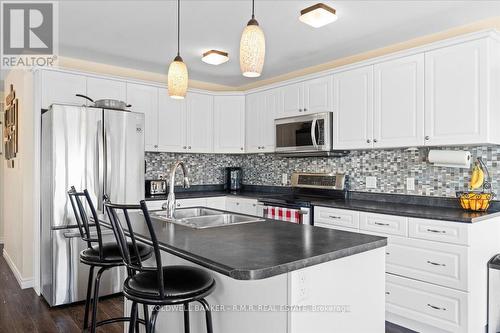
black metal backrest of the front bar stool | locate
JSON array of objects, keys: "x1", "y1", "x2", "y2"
[{"x1": 104, "y1": 198, "x2": 165, "y2": 298}]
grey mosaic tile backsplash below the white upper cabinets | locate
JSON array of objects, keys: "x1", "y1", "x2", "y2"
[{"x1": 146, "y1": 146, "x2": 500, "y2": 197}]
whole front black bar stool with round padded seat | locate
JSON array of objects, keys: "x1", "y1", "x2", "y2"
[{"x1": 104, "y1": 200, "x2": 215, "y2": 333}]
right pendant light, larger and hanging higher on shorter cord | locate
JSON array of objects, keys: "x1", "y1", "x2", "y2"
[{"x1": 240, "y1": 0, "x2": 266, "y2": 77}]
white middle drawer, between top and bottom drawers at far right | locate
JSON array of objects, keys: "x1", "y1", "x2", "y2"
[{"x1": 386, "y1": 237, "x2": 469, "y2": 291}]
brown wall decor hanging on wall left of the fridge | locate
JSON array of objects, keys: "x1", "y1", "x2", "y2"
[{"x1": 3, "y1": 84, "x2": 19, "y2": 168}]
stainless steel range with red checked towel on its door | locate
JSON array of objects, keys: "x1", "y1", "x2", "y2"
[{"x1": 259, "y1": 172, "x2": 349, "y2": 225}]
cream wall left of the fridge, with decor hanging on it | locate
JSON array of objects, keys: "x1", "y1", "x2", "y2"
[{"x1": 3, "y1": 71, "x2": 34, "y2": 288}]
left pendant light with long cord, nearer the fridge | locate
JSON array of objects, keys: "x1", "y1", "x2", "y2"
[{"x1": 168, "y1": 0, "x2": 188, "y2": 99}]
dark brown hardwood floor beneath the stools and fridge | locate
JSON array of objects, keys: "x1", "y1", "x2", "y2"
[{"x1": 0, "y1": 245, "x2": 413, "y2": 333}]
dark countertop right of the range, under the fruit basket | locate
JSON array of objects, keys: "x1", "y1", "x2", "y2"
[{"x1": 312, "y1": 199, "x2": 500, "y2": 223}]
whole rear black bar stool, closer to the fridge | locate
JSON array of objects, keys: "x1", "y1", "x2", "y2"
[{"x1": 68, "y1": 186, "x2": 153, "y2": 333}]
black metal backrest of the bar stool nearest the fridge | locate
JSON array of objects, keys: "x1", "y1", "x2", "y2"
[{"x1": 68, "y1": 186, "x2": 104, "y2": 260}]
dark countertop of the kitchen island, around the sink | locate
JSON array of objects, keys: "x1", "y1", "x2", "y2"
[{"x1": 100, "y1": 213, "x2": 387, "y2": 280}]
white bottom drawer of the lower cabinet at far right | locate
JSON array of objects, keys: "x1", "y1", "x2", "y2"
[{"x1": 386, "y1": 274, "x2": 468, "y2": 333}]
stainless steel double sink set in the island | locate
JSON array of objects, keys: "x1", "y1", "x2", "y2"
[{"x1": 150, "y1": 207, "x2": 264, "y2": 229}]
